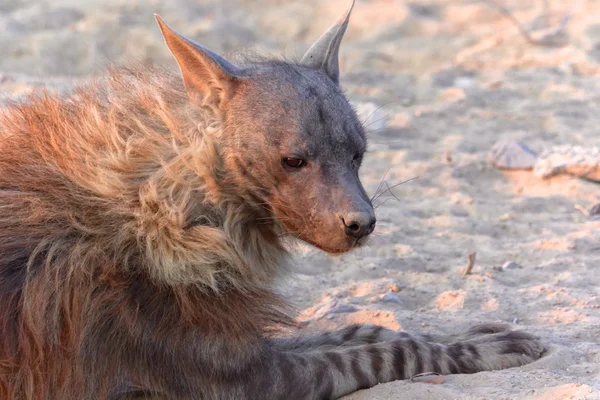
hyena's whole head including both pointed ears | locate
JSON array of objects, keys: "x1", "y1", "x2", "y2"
[{"x1": 157, "y1": 0, "x2": 375, "y2": 253}]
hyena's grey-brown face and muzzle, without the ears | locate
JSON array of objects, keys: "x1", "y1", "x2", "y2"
[{"x1": 224, "y1": 63, "x2": 375, "y2": 253}]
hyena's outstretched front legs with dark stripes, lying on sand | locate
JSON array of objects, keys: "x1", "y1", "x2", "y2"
[{"x1": 255, "y1": 325, "x2": 545, "y2": 399}]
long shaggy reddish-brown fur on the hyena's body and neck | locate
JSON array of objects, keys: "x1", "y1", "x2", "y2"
[{"x1": 0, "y1": 70, "x2": 289, "y2": 400}]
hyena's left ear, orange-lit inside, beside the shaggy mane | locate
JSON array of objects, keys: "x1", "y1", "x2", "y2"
[{"x1": 154, "y1": 14, "x2": 241, "y2": 105}]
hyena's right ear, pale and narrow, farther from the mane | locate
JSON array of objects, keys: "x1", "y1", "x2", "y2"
[{"x1": 301, "y1": 0, "x2": 354, "y2": 84}]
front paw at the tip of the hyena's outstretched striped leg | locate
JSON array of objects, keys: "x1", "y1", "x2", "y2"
[{"x1": 449, "y1": 331, "x2": 546, "y2": 372}]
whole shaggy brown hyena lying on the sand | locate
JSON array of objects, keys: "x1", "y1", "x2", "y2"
[{"x1": 0, "y1": 1, "x2": 543, "y2": 400}]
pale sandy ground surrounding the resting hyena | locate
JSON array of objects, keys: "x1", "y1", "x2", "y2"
[{"x1": 0, "y1": 0, "x2": 600, "y2": 400}]
